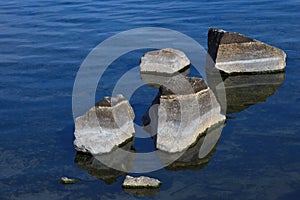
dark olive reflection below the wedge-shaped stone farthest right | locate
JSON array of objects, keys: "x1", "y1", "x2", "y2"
[{"x1": 224, "y1": 72, "x2": 285, "y2": 113}]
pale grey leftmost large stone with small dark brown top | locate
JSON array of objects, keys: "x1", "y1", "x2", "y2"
[{"x1": 74, "y1": 95, "x2": 134, "y2": 154}]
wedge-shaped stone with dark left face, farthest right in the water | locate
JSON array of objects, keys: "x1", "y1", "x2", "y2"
[{"x1": 208, "y1": 28, "x2": 286, "y2": 74}]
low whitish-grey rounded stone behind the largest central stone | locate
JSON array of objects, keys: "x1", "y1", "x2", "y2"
[{"x1": 140, "y1": 48, "x2": 190, "y2": 74}]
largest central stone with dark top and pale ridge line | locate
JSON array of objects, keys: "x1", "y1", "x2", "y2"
[{"x1": 143, "y1": 78, "x2": 225, "y2": 153}]
